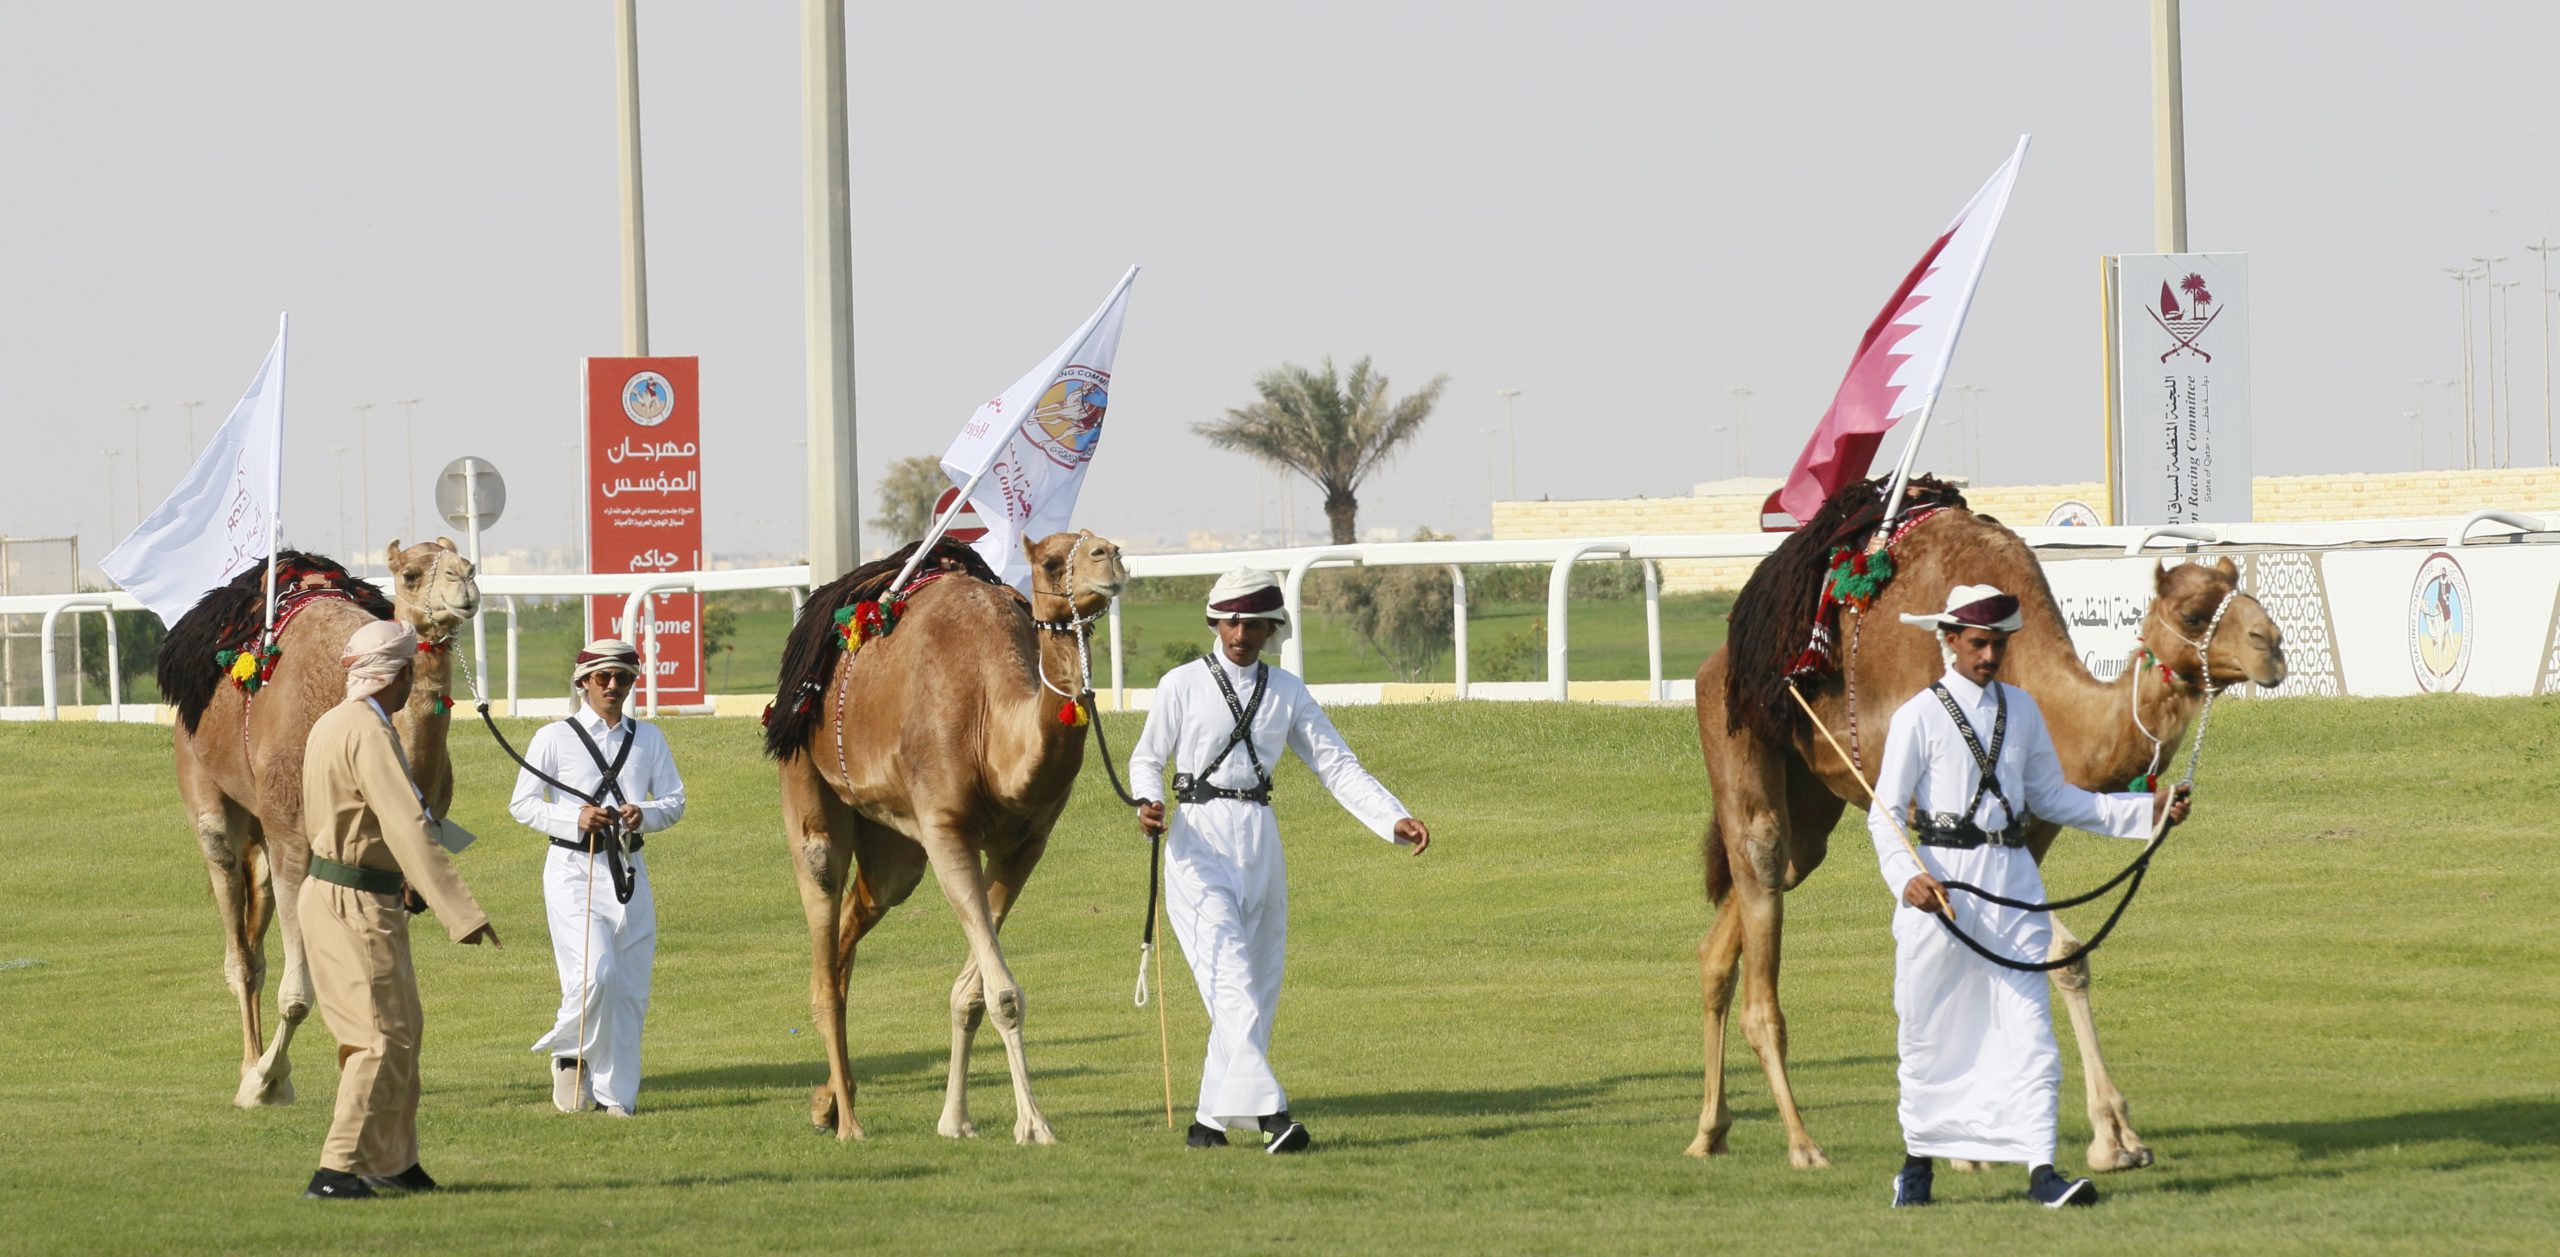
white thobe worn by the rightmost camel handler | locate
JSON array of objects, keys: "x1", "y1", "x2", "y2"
[{"x1": 1866, "y1": 671, "x2": 2153, "y2": 1165}]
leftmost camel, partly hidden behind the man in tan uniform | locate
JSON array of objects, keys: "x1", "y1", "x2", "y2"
[{"x1": 159, "y1": 538, "x2": 479, "y2": 1109}]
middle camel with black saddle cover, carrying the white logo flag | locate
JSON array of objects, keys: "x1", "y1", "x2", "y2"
[{"x1": 765, "y1": 532, "x2": 1129, "y2": 1144}]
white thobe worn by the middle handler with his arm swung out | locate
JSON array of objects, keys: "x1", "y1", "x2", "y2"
[{"x1": 1129, "y1": 653, "x2": 1408, "y2": 1129}]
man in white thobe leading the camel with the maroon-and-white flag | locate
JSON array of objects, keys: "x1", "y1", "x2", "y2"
[{"x1": 1866, "y1": 584, "x2": 2186, "y2": 1208}]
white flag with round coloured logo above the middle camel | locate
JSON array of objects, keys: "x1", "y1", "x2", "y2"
[{"x1": 942, "y1": 266, "x2": 1137, "y2": 591}]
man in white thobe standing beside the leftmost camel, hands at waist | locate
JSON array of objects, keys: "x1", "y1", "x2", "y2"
[{"x1": 507, "y1": 637, "x2": 684, "y2": 1116}]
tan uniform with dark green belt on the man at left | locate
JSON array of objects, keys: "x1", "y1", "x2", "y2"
[{"x1": 300, "y1": 699, "x2": 489, "y2": 1175}]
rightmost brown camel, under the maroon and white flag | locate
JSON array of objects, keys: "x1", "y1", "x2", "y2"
[{"x1": 1690, "y1": 494, "x2": 2284, "y2": 1170}]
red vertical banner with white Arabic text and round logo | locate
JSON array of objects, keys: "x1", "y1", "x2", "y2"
[{"x1": 581, "y1": 358, "x2": 704, "y2": 701}]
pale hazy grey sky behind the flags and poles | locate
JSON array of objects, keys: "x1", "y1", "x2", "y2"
[{"x1": 0, "y1": 0, "x2": 2560, "y2": 563}]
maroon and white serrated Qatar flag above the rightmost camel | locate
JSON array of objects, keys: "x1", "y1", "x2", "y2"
[{"x1": 1761, "y1": 136, "x2": 2028, "y2": 532}]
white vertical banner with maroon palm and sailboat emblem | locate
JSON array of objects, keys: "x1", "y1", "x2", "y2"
[{"x1": 2107, "y1": 253, "x2": 2253, "y2": 525}]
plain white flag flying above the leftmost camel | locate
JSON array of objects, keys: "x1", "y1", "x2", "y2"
[{"x1": 97, "y1": 323, "x2": 287, "y2": 625}]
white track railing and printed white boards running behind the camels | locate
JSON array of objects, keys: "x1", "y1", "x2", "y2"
[{"x1": 0, "y1": 509, "x2": 2560, "y2": 722}]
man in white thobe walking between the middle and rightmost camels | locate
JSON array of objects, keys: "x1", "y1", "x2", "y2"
[{"x1": 1129, "y1": 568, "x2": 1431, "y2": 1152}]
